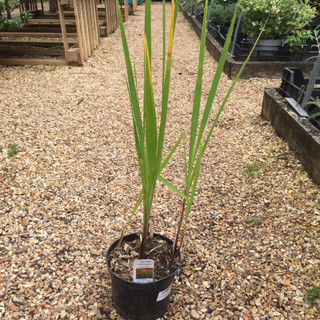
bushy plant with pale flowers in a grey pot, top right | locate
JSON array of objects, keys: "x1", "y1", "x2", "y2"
[{"x1": 238, "y1": 0, "x2": 316, "y2": 51}]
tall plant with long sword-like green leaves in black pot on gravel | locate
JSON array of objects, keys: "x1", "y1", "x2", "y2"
[{"x1": 106, "y1": 0, "x2": 266, "y2": 320}]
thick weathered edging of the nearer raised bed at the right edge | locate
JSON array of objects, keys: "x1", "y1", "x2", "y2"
[{"x1": 261, "y1": 88, "x2": 320, "y2": 185}]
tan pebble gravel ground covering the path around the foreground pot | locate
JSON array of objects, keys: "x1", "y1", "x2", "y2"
[{"x1": 0, "y1": 3, "x2": 320, "y2": 320}]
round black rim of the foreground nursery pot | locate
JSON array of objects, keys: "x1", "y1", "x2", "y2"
[{"x1": 106, "y1": 232, "x2": 181, "y2": 287}]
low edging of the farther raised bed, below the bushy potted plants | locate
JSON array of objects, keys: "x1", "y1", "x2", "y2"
[{"x1": 180, "y1": 5, "x2": 314, "y2": 78}]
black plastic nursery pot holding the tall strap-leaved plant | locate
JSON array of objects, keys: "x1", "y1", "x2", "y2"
[{"x1": 106, "y1": 233, "x2": 181, "y2": 320}]
